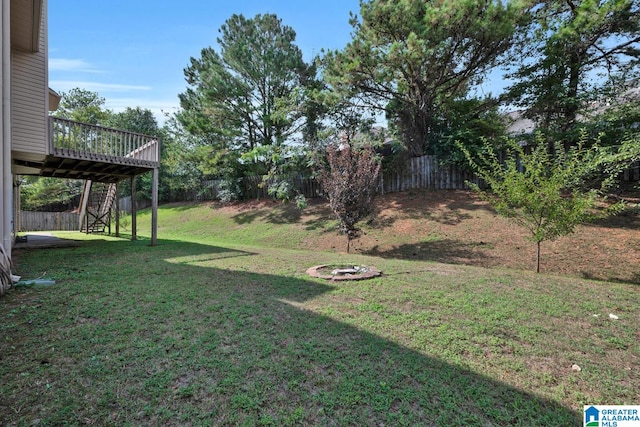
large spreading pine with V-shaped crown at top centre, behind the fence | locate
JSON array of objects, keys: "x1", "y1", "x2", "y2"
[{"x1": 324, "y1": 0, "x2": 524, "y2": 156}]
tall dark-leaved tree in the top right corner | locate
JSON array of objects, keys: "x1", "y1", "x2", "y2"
[{"x1": 509, "y1": 0, "x2": 640, "y2": 145}]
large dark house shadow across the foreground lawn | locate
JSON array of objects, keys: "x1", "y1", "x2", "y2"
[{"x1": 0, "y1": 240, "x2": 579, "y2": 426}]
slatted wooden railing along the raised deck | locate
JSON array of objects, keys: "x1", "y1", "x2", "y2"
[{"x1": 49, "y1": 117, "x2": 160, "y2": 168}]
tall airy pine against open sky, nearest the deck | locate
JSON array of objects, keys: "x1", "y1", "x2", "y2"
[{"x1": 178, "y1": 14, "x2": 307, "y2": 177}]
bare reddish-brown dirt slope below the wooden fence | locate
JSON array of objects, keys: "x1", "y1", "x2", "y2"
[{"x1": 292, "y1": 191, "x2": 640, "y2": 283}]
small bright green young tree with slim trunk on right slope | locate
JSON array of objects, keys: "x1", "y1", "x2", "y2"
[{"x1": 460, "y1": 135, "x2": 620, "y2": 272}]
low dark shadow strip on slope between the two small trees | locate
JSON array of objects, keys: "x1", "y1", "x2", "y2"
[{"x1": 362, "y1": 239, "x2": 495, "y2": 266}]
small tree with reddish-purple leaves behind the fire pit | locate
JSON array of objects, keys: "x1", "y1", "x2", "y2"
[{"x1": 318, "y1": 143, "x2": 381, "y2": 253}]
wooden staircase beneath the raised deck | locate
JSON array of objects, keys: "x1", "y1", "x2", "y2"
[{"x1": 80, "y1": 180, "x2": 117, "y2": 234}]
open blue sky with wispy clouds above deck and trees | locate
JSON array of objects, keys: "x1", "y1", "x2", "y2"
[{"x1": 49, "y1": 0, "x2": 359, "y2": 121}]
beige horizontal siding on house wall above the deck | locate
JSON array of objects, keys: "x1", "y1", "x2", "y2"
[{"x1": 11, "y1": 0, "x2": 49, "y2": 154}]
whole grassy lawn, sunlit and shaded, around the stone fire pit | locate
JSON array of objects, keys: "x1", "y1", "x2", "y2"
[{"x1": 0, "y1": 199, "x2": 640, "y2": 426}]
